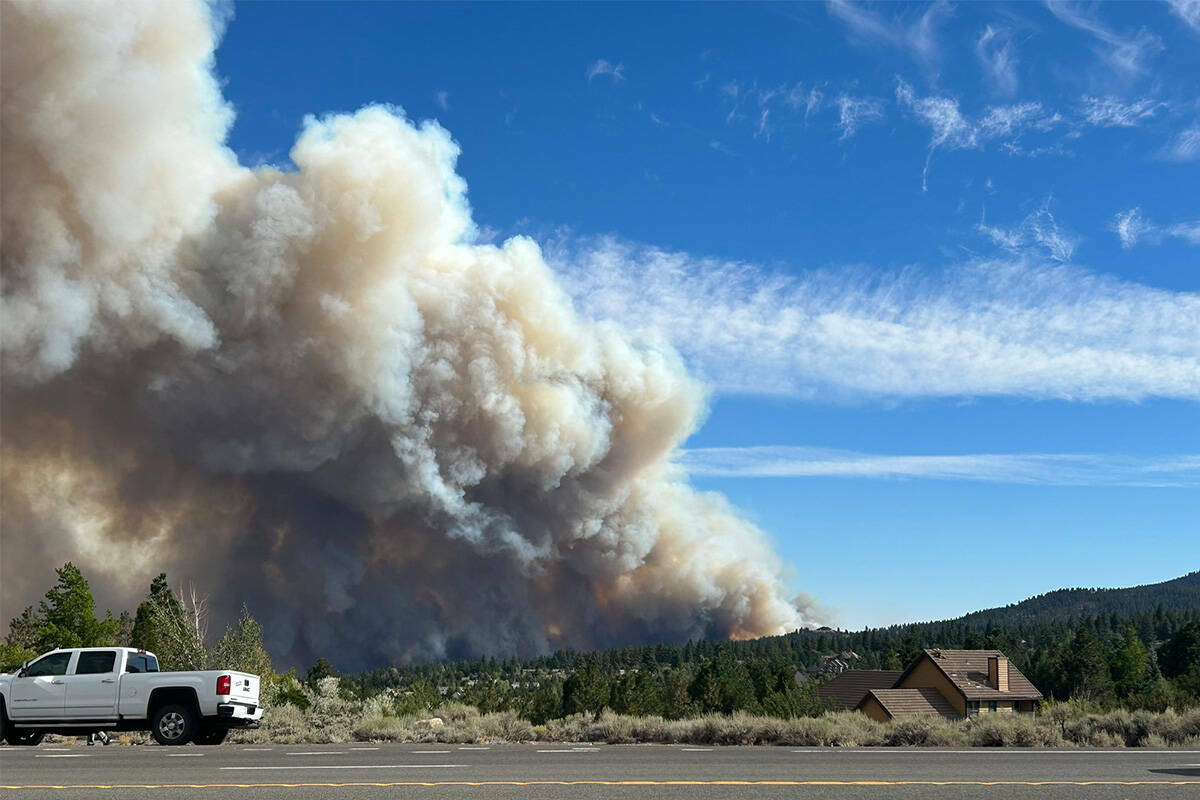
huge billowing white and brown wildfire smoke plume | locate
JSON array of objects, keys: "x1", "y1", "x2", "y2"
[{"x1": 0, "y1": 0, "x2": 805, "y2": 667}]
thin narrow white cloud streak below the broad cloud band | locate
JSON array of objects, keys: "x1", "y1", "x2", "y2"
[{"x1": 679, "y1": 446, "x2": 1200, "y2": 488}]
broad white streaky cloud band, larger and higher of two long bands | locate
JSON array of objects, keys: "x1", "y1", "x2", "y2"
[{"x1": 548, "y1": 235, "x2": 1200, "y2": 401}]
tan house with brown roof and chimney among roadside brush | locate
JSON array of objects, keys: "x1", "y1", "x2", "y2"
[{"x1": 817, "y1": 650, "x2": 1042, "y2": 722}]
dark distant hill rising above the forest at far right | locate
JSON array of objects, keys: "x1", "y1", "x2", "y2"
[{"x1": 953, "y1": 571, "x2": 1200, "y2": 628}]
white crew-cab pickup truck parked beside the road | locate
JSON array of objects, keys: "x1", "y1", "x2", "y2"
[{"x1": 0, "y1": 648, "x2": 263, "y2": 745}]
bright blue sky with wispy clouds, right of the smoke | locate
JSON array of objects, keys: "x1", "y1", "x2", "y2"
[{"x1": 217, "y1": 1, "x2": 1200, "y2": 627}]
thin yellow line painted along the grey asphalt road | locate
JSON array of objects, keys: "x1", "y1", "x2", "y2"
[{"x1": 0, "y1": 780, "x2": 1200, "y2": 789}]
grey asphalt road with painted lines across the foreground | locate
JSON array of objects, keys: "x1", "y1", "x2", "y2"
[{"x1": 0, "y1": 744, "x2": 1200, "y2": 800}]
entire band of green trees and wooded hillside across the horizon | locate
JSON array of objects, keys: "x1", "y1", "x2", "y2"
[{"x1": 0, "y1": 564, "x2": 1200, "y2": 724}]
